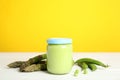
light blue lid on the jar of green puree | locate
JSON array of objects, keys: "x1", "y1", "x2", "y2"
[{"x1": 47, "y1": 38, "x2": 72, "y2": 44}]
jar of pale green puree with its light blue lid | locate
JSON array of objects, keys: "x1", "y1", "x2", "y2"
[{"x1": 47, "y1": 38, "x2": 73, "y2": 74}]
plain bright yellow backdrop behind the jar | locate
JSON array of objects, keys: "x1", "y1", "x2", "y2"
[{"x1": 0, "y1": 0, "x2": 120, "y2": 52}]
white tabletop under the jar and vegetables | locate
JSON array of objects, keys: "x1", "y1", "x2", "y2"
[{"x1": 0, "y1": 52, "x2": 120, "y2": 80}]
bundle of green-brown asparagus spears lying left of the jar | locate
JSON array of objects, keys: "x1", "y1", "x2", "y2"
[{"x1": 8, "y1": 54, "x2": 47, "y2": 72}]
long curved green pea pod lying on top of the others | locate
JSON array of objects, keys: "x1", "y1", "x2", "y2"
[{"x1": 75, "y1": 58, "x2": 108, "y2": 67}]
